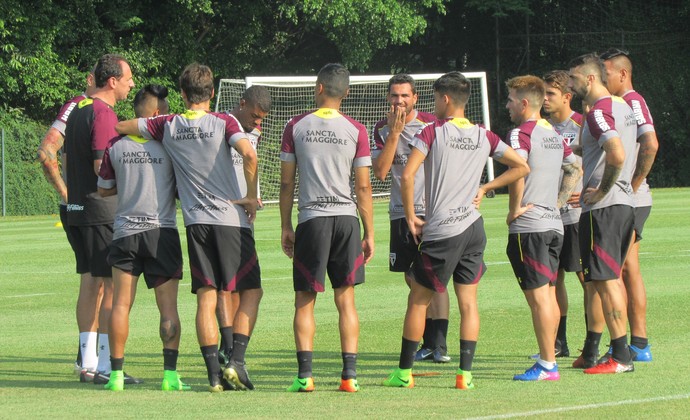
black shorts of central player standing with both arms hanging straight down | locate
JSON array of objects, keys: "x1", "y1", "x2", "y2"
[{"x1": 292, "y1": 216, "x2": 364, "y2": 292}]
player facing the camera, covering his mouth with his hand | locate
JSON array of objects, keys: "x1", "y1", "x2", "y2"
[{"x1": 371, "y1": 74, "x2": 450, "y2": 363}]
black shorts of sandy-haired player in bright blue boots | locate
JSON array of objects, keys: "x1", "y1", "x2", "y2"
[{"x1": 506, "y1": 230, "x2": 563, "y2": 290}]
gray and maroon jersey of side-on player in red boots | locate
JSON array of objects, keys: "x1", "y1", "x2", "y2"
[{"x1": 580, "y1": 96, "x2": 637, "y2": 212}]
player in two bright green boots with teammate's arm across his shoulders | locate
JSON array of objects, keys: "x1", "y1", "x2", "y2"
[{"x1": 98, "y1": 85, "x2": 190, "y2": 391}]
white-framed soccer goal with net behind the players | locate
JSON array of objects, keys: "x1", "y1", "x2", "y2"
[{"x1": 216, "y1": 72, "x2": 494, "y2": 203}]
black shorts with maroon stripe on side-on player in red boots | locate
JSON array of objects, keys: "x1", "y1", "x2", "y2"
[{"x1": 580, "y1": 205, "x2": 633, "y2": 282}]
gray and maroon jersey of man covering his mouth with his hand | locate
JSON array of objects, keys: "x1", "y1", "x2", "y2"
[{"x1": 371, "y1": 111, "x2": 436, "y2": 220}]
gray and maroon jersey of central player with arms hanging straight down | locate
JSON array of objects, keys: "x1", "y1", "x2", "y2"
[{"x1": 280, "y1": 108, "x2": 371, "y2": 223}]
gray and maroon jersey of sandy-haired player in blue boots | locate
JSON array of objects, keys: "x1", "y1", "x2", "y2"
[{"x1": 508, "y1": 119, "x2": 575, "y2": 234}]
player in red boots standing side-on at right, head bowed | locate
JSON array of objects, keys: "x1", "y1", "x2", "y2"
[{"x1": 569, "y1": 54, "x2": 637, "y2": 374}]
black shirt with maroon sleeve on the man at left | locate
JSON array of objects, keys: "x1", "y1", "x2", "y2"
[{"x1": 64, "y1": 98, "x2": 118, "y2": 226}]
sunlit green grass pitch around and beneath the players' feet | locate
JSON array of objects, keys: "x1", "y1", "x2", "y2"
[{"x1": 0, "y1": 189, "x2": 690, "y2": 418}]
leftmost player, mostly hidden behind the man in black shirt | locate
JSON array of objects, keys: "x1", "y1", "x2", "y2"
[{"x1": 36, "y1": 70, "x2": 103, "y2": 375}]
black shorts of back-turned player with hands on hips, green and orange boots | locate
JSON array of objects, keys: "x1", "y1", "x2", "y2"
[{"x1": 410, "y1": 217, "x2": 486, "y2": 293}]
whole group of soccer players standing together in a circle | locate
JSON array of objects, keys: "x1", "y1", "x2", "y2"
[{"x1": 38, "y1": 50, "x2": 657, "y2": 392}]
